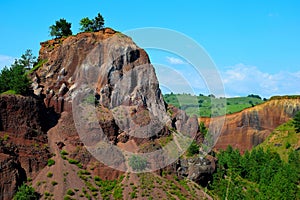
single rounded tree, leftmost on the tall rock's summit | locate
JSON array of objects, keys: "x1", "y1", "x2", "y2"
[{"x1": 49, "y1": 19, "x2": 72, "y2": 38}]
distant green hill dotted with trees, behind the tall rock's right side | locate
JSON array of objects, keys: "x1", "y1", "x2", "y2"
[{"x1": 164, "y1": 93, "x2": 266, "y2": 117}]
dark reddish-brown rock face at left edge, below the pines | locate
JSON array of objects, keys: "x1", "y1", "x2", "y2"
[{"x1": 0, "y1": 95, "x2": 55, "y2": 199}]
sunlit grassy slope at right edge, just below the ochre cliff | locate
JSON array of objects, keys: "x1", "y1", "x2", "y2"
[{"x1": 257, "y1": 120, "x2": 300, "y2": 161}]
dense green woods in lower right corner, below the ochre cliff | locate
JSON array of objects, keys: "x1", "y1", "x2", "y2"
[{"x1": 209, "y1": 147, "x2": 300, "y2": 199}]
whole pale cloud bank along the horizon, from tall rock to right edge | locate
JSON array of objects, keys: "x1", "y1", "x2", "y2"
[{"x1": 155, "y1": 61, "x2": 300, "y2": 98}]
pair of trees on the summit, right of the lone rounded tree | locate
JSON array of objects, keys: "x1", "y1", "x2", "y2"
[{"x1": 80, "y1": 13, "x2": 104, "y2": 32}]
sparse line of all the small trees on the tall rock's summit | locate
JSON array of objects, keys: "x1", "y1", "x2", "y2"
[{"x1": 49, "y1": 13, "x2": 104, "y2": 38}]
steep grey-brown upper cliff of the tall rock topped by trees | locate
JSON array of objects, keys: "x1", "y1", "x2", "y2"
[{"x1": 33, "y1": 29, "x2": 165, "y2": 117}]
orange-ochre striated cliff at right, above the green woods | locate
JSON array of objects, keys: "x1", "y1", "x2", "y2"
[{"x1": 200, "y1": 99, "x2": 300, "y2": 152}]
